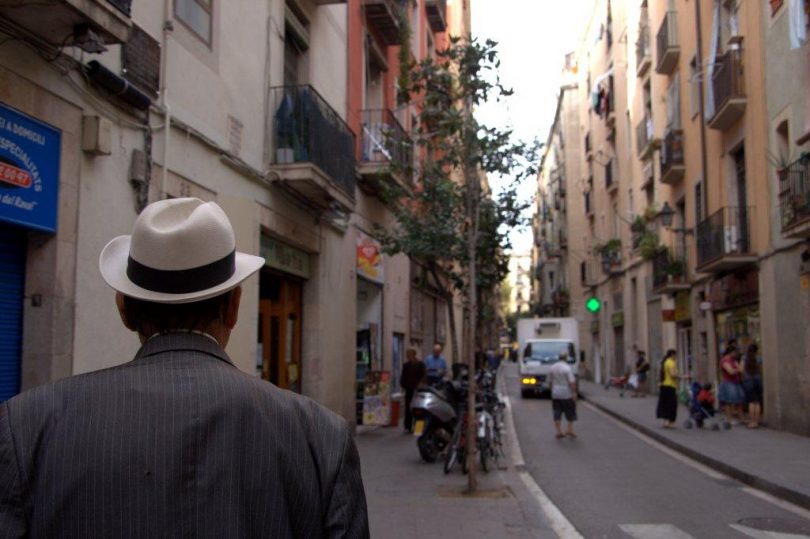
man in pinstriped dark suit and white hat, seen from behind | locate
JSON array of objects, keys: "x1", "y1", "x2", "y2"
[{"x1": 0, "y1": 198, "x2": 369, "y2": 538}]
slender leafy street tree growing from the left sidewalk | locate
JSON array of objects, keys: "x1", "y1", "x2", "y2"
[{"x1": 376, "y1": 38, "x2": 536, "y2": 491}]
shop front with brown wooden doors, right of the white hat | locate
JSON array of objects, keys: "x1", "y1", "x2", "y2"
[{"x1": 256, "y1": 235, "x2": 310, "y2": 393}]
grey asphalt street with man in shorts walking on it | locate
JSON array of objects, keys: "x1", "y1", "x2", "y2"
[{"x1": 503, "y1": 364, "x2": 810, "y2": 538}]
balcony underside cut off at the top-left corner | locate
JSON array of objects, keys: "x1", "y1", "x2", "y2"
[{"x1": 0, "y1": 0, "x2": 132, "y2": 47}]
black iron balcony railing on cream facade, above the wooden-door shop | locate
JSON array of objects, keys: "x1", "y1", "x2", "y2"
[{"x1": 271, "y1": 85, "x2": 355, "y2": 197}]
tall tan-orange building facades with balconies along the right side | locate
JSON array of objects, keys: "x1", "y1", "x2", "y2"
[{"x1": 540, "y1": 0, "x2": 810, "y2": 433}]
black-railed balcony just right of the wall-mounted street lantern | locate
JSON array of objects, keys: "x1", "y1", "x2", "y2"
[{"x1": 696, "y1": 206, "x2": 757, "y2": 273}]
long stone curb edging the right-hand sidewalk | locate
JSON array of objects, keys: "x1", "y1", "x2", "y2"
[{"x1": 582, "y1": 394, "x2": 810, "y2": 510}]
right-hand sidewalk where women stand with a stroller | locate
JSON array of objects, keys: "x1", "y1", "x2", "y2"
[{"x1": 579, "y1": 380, "x2": 810, "y2": 509}]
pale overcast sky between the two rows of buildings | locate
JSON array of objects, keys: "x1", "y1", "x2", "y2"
[{"x1": 468, "y1": 0, "x2": 593, "y2": 251}]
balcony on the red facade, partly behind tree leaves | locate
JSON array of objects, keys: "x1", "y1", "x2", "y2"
[{"x1": 357, "y1": 109, "x2": 413, "y2": 193}]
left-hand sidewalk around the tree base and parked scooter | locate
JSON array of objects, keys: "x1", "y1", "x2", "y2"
[{"x1": 355, "y1": 414, "x2": 557, "y2": 539}]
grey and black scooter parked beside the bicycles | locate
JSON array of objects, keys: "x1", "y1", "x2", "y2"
[{"x1": 411, "y1": 381, "x2": 466, "y2": 462}]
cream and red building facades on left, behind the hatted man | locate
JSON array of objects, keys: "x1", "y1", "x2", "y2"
[{"x1": 0, "y1": 0, "x2": 469, "y2": 428}]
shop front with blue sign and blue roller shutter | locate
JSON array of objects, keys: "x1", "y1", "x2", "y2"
[{"x1": 0, "y1": 103, "x2": 61, "y2": 402}]
